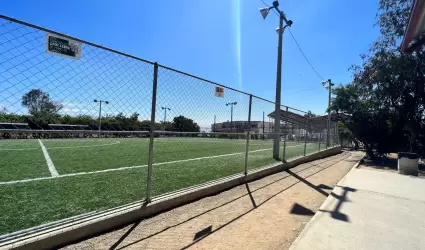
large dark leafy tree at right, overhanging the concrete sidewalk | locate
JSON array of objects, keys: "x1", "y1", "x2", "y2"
[{"x1": 331, "y1": 0, "x2": 425, "y2": 157}]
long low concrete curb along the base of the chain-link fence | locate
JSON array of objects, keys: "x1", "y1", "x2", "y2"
[{"x1": 0, "y1": 147, "x2": 341, "y2": 249}]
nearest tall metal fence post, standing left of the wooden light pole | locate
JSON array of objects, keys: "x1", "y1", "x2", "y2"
[{"x1": 146, "y1": 62, "x2": 158, "y2": 203}]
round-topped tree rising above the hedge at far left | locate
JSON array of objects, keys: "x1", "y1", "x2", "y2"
[{"x1": 21, "y1": 89, "x2": 63, "y2": 125}]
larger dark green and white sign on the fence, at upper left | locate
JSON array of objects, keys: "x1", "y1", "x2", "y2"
[{"x1": 46, "y1": 33, "x2": 81, "y2": 59}]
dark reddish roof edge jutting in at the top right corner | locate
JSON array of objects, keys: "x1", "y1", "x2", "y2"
[{"x1": 401, "y1": 0, "x2": 425, "y2": 52}]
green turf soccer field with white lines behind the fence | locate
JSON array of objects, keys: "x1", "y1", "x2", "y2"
[{"x1": 0, "y1": 137, "x2": 323, "y2": 235}]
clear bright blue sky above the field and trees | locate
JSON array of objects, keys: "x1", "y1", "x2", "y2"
[{"x1": 0, "y1": 0, "x2": 379, "y2": 129}]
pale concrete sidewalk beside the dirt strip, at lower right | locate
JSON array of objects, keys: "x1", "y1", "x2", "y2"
[{"x1": 290, "y1": 163, "x2": 425, "y2": 250}]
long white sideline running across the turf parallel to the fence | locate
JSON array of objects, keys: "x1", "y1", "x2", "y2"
[{"x1": 0, "y1": 143, "x2": 311, "y2": 185}]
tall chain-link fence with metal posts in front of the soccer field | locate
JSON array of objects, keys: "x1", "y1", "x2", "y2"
[{"x1": 0, "y1": 16, "x2": 338, "y2": 238}]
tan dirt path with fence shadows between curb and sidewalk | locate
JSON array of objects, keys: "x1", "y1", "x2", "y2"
[{"x1": 66, "y1": 152, "x2": 362, "y2": 249}]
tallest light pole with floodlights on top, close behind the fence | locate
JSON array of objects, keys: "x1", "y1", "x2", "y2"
[{"x1": 260, "y1": 1, "x2": 292, "y2": 159}]
